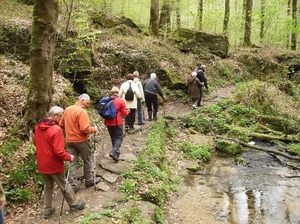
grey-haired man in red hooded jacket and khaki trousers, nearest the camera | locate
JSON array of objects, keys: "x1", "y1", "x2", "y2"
[{"x1": 34, "y1": 106, "x2": 86, "y2": 219}]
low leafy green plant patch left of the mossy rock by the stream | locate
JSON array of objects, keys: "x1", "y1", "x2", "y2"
[{"x1": 179, "y1": 142, "x2": 211, "y2": 162}]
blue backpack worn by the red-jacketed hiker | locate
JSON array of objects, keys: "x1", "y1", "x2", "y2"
[{"x1": 98, "y1": 96, "x2": 117, "y2": 120}]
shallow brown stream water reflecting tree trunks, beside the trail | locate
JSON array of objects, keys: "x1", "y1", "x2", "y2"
[{"x1": 167, "y1": 143, "x2": 300, "y2": 224}]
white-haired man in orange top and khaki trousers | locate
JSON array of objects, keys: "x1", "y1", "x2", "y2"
[{"x1": 59, "y1": 93, "x2": 100, "y2": 192}]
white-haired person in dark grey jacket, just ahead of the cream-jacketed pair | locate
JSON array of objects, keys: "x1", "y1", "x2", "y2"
[{"x1": 143, "y1": 73, "x2": 165, "y2": 121}]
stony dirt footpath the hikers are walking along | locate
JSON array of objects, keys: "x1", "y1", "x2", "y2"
[{"x1": 6, "y1": 87, "x2": 235, "y2": 224}]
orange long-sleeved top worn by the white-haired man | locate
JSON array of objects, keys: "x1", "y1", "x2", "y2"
[{"x1": 59, "y1": 102, "x2": 96, "y2": 142}]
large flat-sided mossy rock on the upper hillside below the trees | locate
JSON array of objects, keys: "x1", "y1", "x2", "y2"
[{"x1": 173, "y1": 29, "x2": 229, "y2": 58}]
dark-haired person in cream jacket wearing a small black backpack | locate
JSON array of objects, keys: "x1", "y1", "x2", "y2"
[{"x1": 119, "y1": 73, "x2": 142, "y2": 132}]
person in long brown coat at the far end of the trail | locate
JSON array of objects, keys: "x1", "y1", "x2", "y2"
[{"x1": 187, "y1": 72, "x2": 204, "y2": 109}]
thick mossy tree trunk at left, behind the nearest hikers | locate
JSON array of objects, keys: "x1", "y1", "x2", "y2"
[{"x1": 24, "y1": 0, "x2": 58, "y2": 131}]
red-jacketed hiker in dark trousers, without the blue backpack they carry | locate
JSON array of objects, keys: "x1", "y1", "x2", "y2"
[{"x1": 105, "y1": 86, "x2": 130, "y2": 162}]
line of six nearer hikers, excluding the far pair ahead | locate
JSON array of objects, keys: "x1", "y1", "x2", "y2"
[{"x1": 34, "y1": 71, "x2": 164, "y2": 219}]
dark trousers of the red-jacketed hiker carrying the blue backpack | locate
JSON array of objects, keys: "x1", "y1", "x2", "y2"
[{"x1": 107, "y1": 125, "x2": 124, "y2": 156}]
